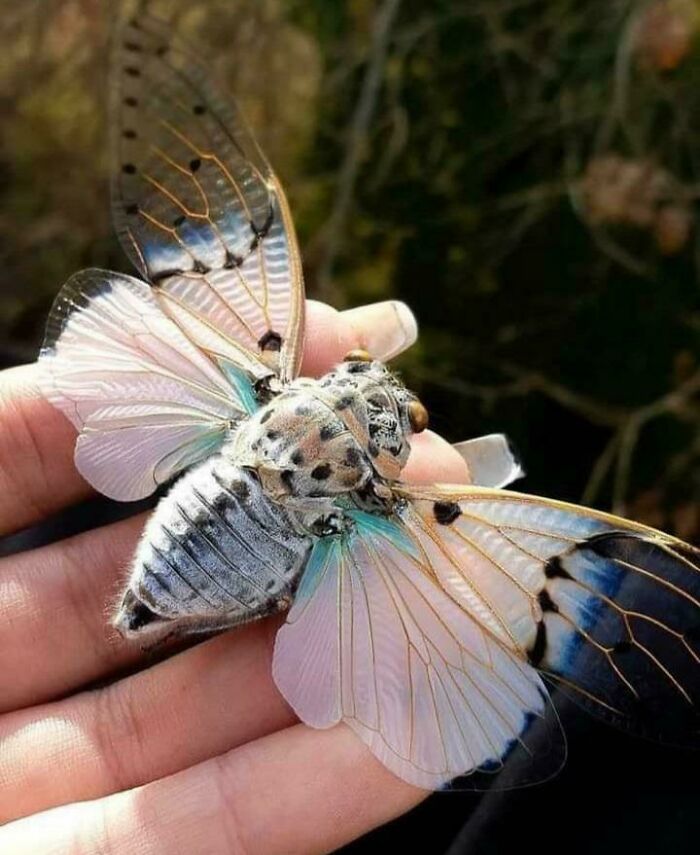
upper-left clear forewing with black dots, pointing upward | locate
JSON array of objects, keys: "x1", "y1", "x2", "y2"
[{"x1": 112, "y1": 14, "x2": 304, "y2": 380}]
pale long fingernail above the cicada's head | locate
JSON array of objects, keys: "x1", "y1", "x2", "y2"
[{"x1": 343, "y1": 300, "x2": 418, "y2": 361}]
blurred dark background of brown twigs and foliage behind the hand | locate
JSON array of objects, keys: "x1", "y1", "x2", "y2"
[{"x1": 0, "y1": 0, "x2": 700, "y2": 855}]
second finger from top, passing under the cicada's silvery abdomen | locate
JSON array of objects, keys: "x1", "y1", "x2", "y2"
[{"x1": 0, "y1": 424, "x2": 466, "y2": 710}]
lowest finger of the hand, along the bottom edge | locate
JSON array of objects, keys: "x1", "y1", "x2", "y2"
[{"x1": 0, "y1": 725, "x2": 428, "y2": 855}]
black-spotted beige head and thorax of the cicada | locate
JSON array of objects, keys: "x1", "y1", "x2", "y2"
[{"x1": 224, "y1": 362, "x2": 415, "y2": 501}]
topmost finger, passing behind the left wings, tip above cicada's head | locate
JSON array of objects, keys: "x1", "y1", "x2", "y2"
[{"x1": 0, "y1": 300, "x2": 417, "y2": 536}]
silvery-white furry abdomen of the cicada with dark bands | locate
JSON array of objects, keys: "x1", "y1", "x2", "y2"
[{"x1": 115, "y1": 455, "x2": 310, "y2": 634}]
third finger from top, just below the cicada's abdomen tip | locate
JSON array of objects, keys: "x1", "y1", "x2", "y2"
[{"x1": 0, "y1": 617, "x2": 296, "y2": 824}]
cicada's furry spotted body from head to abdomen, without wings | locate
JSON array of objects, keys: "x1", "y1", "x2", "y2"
[{"x1": 115, "y1": 359, "x2": 417, "y2": 635}]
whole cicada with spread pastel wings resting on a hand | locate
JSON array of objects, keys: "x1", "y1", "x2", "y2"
[{"x1": 41, "y1": 15, "x2": 700, "y2": 788}]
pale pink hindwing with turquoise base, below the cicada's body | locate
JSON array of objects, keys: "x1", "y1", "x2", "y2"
[{"x1": 273, "y1": 511, "x2": 547, "y2": 788}]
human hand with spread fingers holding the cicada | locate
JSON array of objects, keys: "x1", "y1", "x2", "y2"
[{"x1": 0, "y1": 302, "x2": 467, "y2": 855}]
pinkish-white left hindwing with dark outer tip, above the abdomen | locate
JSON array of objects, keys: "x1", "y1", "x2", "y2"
[{"x1": 41, "y1": 270, "x2": 258, "y2": 501}]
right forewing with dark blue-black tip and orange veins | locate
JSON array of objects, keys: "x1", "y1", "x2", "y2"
[{"x1": 401, "y1": 485, "x2": 700, "y2": 744}]
